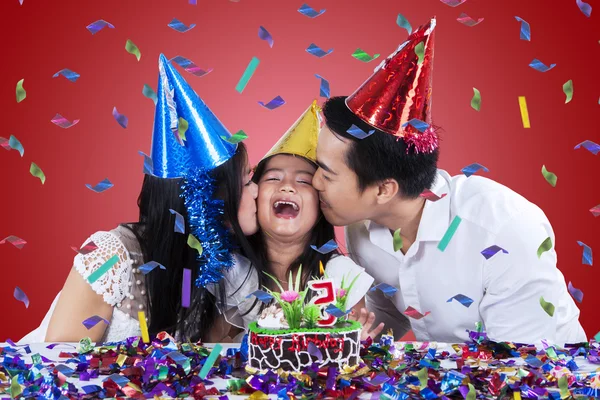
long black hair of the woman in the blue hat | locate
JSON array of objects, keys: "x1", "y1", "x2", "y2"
[{"x1": 125, "y1": 143, "x2": 254, "y2": 341}]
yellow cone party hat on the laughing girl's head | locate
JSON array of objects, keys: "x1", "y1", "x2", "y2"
[{"x1": 262, "y1": 100, "x2": 321, "y2": 163}]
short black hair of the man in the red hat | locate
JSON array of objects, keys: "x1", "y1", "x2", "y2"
[{"x1": 323, "y1": 96, "x2": 439, "y2": 199}]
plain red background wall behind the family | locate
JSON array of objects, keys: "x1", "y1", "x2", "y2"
[{"x1": 0, "y1": 0, "x2": 600, "y2": 341}]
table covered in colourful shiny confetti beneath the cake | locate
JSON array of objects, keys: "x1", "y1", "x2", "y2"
[{"x1": 0, "y1": 338, "x2": 600, "y2": 400}]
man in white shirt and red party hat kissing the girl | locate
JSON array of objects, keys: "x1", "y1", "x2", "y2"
[{"x1": 313, "y1": 20, "x2": 586, "y2": 343}]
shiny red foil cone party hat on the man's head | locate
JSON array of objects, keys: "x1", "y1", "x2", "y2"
[{"x1": 346, "y1": 18, "x2": 438, "y2": 153}]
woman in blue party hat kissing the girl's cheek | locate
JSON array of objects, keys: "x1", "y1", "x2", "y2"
[{"x1": 21, "y1": 55, "x2": 258, "y2": 343}]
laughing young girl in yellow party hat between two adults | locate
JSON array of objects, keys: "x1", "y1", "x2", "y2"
[{"x1": 211, "y1": 102, "x2": 383, "y2": 338}]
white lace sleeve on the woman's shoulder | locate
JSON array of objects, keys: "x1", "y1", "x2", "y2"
[{"x1": 73, "y1": 232, "x2": 133, "y2": 306}]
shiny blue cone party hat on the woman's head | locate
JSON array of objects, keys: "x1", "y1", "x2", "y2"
[{"x1": 151, "y1": 54, "x2": 237, "y2": 178}]
